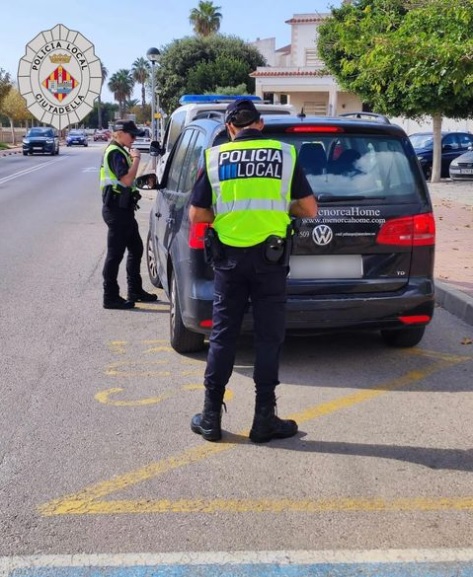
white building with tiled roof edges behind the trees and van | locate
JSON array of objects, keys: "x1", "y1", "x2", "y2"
[{"x1": 250, "y1": 14, "x2": 473, "y2": 134}]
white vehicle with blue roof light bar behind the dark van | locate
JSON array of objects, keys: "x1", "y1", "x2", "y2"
[{"x1": 151, "y1": 94, "x2": 296, "y2": 182}]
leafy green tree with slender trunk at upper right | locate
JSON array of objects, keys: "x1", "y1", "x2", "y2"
[{"x1": 318, "y1": 0, "x2": 473, "y2": 182}]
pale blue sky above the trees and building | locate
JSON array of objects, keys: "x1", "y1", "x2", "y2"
[{"x1": 0, "y1": 0, "x2": 341, "y2": 102}]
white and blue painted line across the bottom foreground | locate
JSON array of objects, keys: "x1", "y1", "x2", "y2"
[{"x1": 0, "y1": 549, "x2": 473, "y2": 577}]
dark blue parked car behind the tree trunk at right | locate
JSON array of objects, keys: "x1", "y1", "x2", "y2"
[{"x1": 409, "y1": 132, "x2": 473, "y2": 179}]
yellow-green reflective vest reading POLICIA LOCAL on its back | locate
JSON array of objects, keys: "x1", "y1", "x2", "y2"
[{"x1": 206, "y1": 139, "x2": 296, "y2": 246}]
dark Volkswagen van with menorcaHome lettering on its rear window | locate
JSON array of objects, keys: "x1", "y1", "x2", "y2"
[{"x1": 138, "y1": 115, "x2": 435, "y2": 353}]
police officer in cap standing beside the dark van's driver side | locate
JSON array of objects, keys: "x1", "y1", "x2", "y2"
[{"x1": 100, "y1": 120, "x2": 158, "y2": 309}]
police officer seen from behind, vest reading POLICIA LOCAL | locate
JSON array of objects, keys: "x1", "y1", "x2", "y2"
[{"x1": 189, "y1": 99, "x2": 317, "y2": 443}]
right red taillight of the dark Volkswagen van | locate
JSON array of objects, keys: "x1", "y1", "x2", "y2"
[{"x1": 376, "y1": 212, "x2": 435, "y2": 246}]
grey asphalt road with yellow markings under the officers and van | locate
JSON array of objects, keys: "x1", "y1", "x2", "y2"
[{"x1": 0, "y1": 144, "x2": 473, "y2": 577}]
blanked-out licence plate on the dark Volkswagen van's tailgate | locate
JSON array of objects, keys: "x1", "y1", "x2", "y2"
[{"x1": 289, "y1": 254, "x2": 363, "y2": 279}]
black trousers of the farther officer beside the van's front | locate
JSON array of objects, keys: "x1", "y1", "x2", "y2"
[{"x1": 102, "y1": 205, "x2": 143, "y2": 300}]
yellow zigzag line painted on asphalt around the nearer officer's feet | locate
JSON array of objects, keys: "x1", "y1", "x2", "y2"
[{"x1": 39, "y1": 355, "x2": 473, "y2": 516}]
